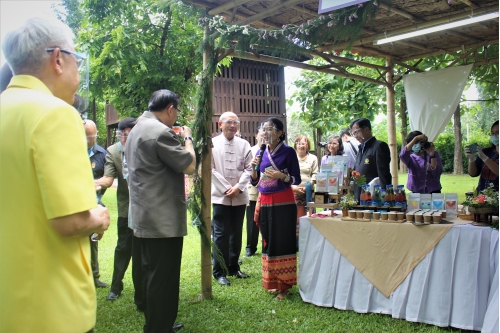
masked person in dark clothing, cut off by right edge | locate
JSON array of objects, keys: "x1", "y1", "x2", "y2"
[{"x1": 465, "y1": 120, "x2": 498, "y2": 191}]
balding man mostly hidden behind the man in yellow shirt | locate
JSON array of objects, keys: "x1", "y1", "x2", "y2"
[{"x1": 84, "y1": 119, "x2": 108, "y2": 288}]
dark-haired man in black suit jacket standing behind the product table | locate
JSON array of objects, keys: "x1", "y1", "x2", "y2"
[{"x1": 350, "y1": 118, "x2": 392, "y2": 201}]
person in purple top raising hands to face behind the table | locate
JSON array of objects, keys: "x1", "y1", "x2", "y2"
[{"x1": 399, "y1": 131, "x2": 443, "y2": 193}]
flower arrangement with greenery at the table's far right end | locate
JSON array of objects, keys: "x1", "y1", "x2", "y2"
[{"x1": 462, "y1": 183, "x2": 498, "y2": 229}]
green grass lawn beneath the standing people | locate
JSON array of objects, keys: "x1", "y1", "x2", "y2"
[{"x1": 95, "y1": 175, "x2": 477, "y2": 333}]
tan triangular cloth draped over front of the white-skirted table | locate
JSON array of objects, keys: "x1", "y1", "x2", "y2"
[{"x1": 308, "y1": 218, "x2": 470, "y2": 297}]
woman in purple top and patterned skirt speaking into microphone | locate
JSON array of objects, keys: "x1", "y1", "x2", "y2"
[{"x1": 251, "y1": 118, "x2": 301, "y2": 300}]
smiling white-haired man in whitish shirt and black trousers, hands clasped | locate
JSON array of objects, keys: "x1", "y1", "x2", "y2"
[{"x1": 212, "y1": 112, "x2": 253, "y2": 286}]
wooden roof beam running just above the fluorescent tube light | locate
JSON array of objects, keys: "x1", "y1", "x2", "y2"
[{"x1": 318, "y1": 5, "x2": 498, "y2": 51}]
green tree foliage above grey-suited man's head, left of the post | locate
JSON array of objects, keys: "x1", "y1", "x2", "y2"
[{"x1": 78, "y1": 0, "x2": 202, "y2": 118}]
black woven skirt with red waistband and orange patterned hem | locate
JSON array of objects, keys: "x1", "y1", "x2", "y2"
[{"x1": 256, "y1": 188, "x2": 297, "y2": 290}]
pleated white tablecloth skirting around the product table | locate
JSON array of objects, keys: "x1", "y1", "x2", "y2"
[{"x1": 299, "y1": 217, "x2": 499, "y2": 332}]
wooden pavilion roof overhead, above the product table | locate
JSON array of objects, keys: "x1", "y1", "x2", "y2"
[{"x1": 184, "y1": 0, "x2": 499, "y2": 84}]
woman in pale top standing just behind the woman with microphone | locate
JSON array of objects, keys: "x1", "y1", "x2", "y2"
[{"x1": 292, "y1": 135, "x2": 319, "y2": 230}]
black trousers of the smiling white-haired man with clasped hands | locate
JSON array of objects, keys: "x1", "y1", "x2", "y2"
[{"x1": 212, "y1": 204, "x2": 246, "y2": 279}]
